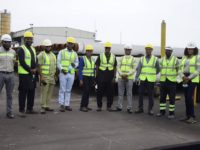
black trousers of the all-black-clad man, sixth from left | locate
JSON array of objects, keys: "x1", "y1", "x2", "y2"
[{"x1": 97, "y1": 80, "x2": 114, "y2": 108}]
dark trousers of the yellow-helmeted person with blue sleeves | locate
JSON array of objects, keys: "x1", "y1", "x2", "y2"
[{"x1": 80, "y1": 76, "x2": 94, "y2": 107}]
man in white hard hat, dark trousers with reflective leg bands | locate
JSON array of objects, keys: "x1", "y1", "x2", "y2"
[{"x1": 157, "y1": 47, "x2": 179, "y2": 119}]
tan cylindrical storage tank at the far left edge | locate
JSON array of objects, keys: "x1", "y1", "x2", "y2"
[{"x1": 0, "y1": 9, "x2": 11, "y2": 36}]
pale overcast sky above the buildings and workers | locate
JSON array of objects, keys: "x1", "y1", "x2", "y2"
[{"x1": 0, "y1": 0, "x2": 200, "y2": 47}]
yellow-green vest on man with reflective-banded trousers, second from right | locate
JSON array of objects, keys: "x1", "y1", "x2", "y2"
[{"x1": 160, "y1": 56, "x2": 178, "y2": 82}]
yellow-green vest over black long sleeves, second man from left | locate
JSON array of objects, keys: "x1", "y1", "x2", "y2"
[{"x1": 18, "y1": 45, "x2": 36, "y2": 74}]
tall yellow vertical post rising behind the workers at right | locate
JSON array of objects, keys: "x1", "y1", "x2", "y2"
[{"x1": 160, "y1": 20, "x2": 166, "y2": 57}]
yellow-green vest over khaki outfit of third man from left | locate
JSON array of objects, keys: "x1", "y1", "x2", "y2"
[{"x1": 41, "y1": 52, "x2": 56, "y2": 75}]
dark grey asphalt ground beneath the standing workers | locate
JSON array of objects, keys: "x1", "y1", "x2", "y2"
[{"x1": 0, "y1": 75, "x2": 200, "y2": 150}]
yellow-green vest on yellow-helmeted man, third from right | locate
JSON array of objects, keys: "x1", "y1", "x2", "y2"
[{"x1": 139, "y1": 56, "x2": 157, "y2": 82}]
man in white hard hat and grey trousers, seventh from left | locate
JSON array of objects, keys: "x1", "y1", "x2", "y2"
[{"x1": 117, "y1": 45, "x2": 135, "y2": 113}]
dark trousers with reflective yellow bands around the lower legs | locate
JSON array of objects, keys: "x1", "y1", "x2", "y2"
[{"x1": 160, "y1": 79, "x2": 176, "y2": 114}]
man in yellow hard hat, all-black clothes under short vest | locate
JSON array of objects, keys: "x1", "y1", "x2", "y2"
[{"x1": 96, "y1": 42, "x2": 117, "y2": 111}]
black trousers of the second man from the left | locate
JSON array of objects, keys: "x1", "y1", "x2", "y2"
[{"x1": 19, "y1": 75, "x2": 36, "y2": 112}]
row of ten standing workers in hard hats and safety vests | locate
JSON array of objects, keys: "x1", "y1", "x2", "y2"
[{"x1": 0, "y1": 31, "x2": 200, "y2": 123}]
